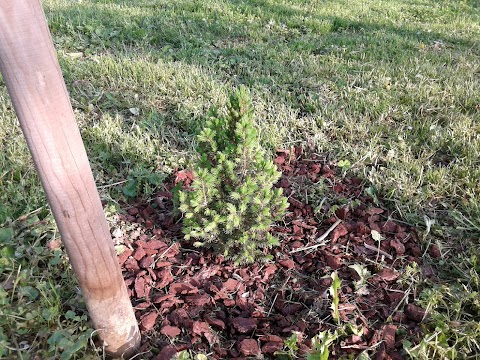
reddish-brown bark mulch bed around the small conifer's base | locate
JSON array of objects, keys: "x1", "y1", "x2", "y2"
[{"x1": 112, "y1": 148, "x2": 425, "y2": 360}]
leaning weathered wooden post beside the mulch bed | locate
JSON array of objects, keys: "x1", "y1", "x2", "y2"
[{"x1": 0, "y1": 0, "x2": 140, "y2": 357}]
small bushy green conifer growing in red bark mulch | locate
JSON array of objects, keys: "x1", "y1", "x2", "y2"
[{"x1": 179, "y1": 87, "x2": 287, "y2": 264}]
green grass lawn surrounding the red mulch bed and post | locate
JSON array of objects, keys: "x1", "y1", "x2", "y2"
[{"x1": 0, "y1": 0, "x2": 480, "y2": 359}]
